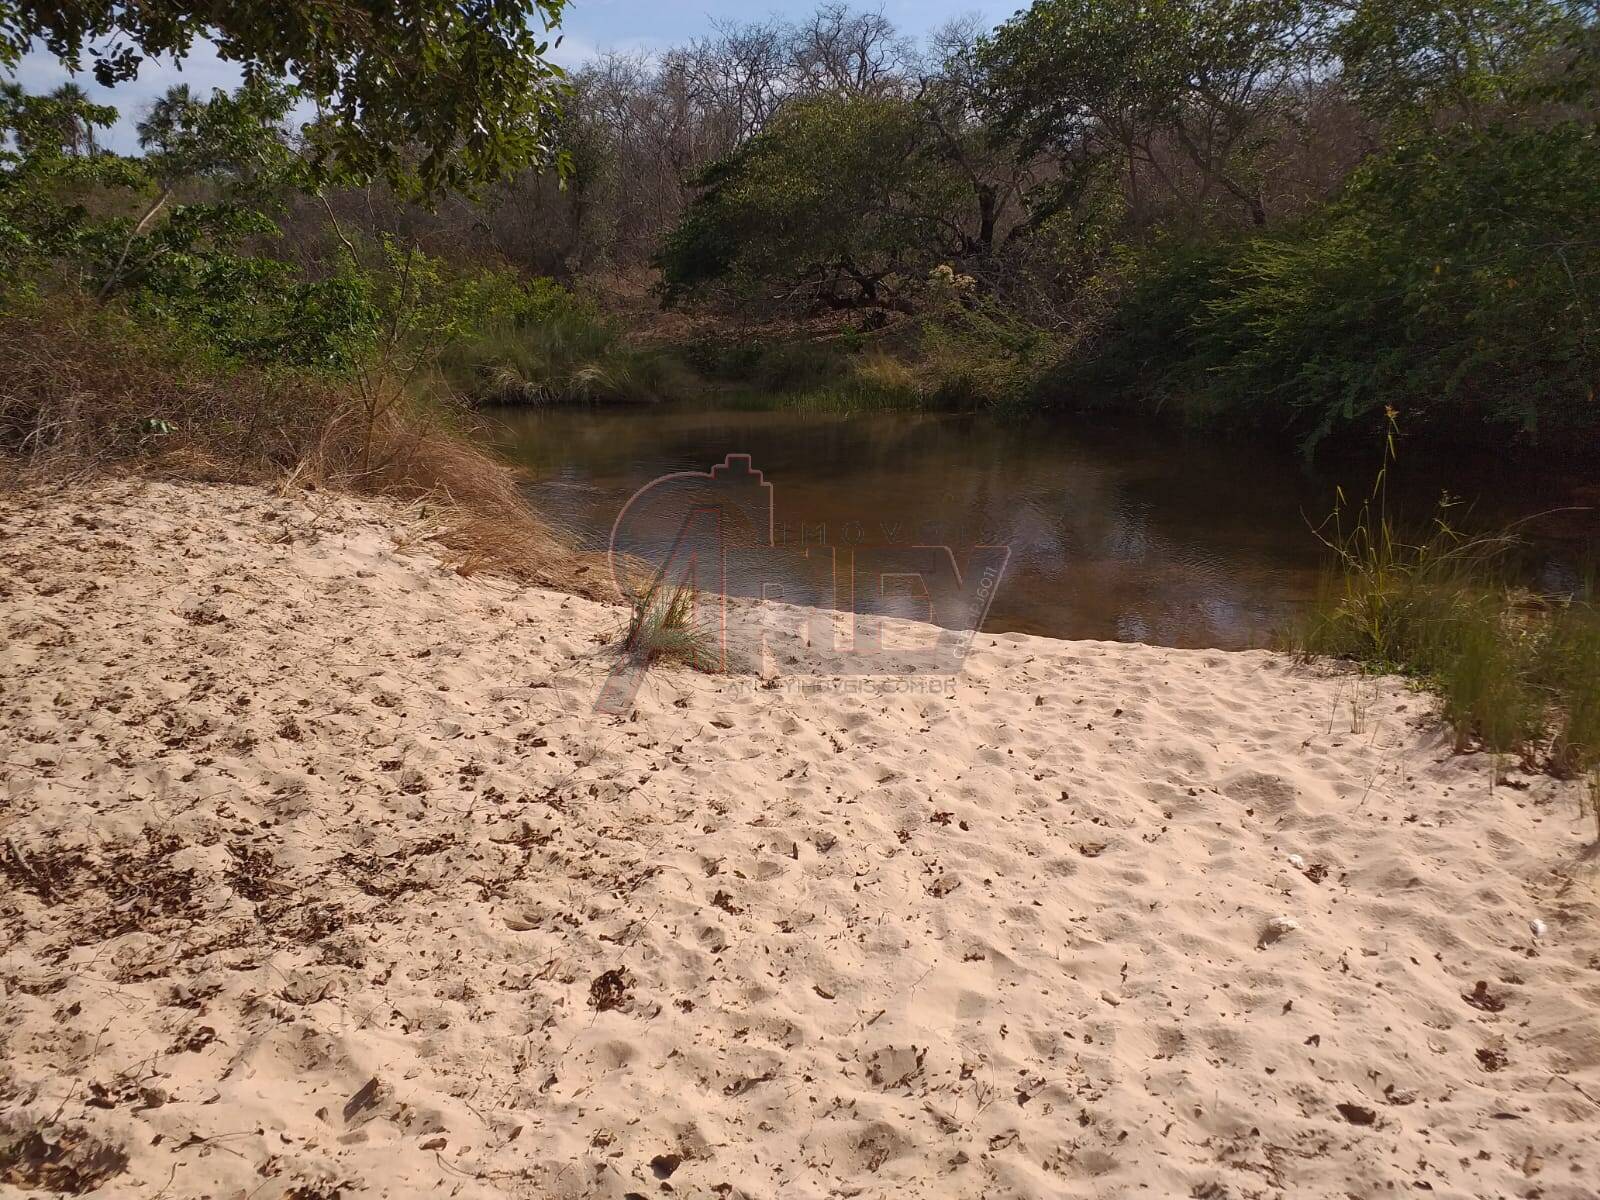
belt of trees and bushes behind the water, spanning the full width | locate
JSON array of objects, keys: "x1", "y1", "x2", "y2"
[{"x1": 0, "y1": 0, "x2": 1600, "y2": 454}]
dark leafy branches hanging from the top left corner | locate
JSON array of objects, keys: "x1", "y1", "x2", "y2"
[{"x1": 0, "y1": 0, "x2": 565, "y2": 190}]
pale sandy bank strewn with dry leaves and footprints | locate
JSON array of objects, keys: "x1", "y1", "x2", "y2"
[{"x1": 9, "y1": 485, "x2": 1600, "y2": 1200}]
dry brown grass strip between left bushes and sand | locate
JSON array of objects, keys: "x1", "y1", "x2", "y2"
[{"x1": 0, "y1": 302, "x2": 614, "y2": 598}]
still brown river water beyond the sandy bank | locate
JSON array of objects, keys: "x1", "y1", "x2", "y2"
[{"x1": 493, "y1": 405, "x2": 1594, "y2": 648}]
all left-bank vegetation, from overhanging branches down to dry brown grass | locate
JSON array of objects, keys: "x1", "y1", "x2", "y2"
[{"x1": 0, "y1": 0, "x2": 619, "y2": 595}]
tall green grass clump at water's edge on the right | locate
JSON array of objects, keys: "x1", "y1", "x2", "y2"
[{"x1": 1296, "y1": 411, "x2": 1600, "y2": 835}]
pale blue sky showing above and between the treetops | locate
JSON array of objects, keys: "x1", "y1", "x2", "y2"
[{"x1": 6, "y1": 0, "x2": 1027, "y2": 152}]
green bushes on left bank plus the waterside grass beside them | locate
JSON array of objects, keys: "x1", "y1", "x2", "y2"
[{"x1": 0, "y1": 72, "x2": 662, "y2": 398}]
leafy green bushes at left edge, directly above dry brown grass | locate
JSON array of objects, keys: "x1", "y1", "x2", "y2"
[{"x1": 0, "y1": 83, "x2": 378, "y2": 368}]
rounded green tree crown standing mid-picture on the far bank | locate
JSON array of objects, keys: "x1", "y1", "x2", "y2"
[{"x1": 658, "y1": 96, "x2": 966, "y2": 302}]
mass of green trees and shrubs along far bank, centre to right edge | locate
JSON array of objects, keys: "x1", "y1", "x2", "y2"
[{"x1": 643, "y1": 0, "x2": 1600, "y2": 450}]
